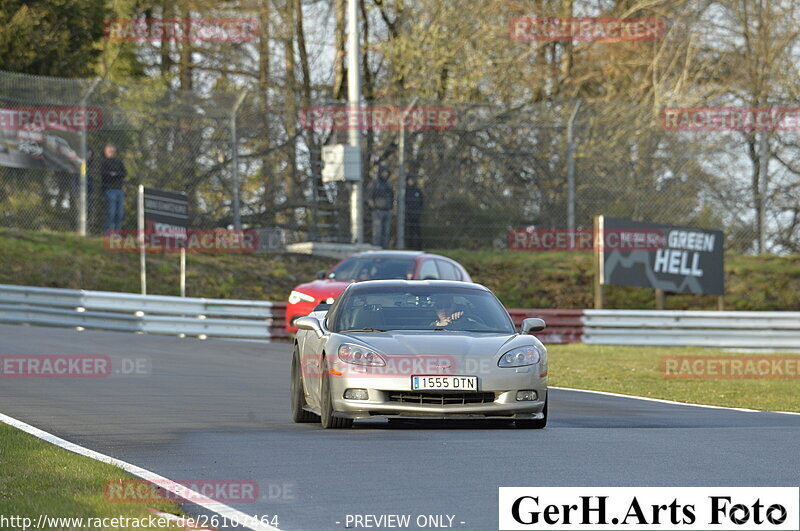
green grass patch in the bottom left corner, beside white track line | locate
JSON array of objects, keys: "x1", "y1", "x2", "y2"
[{"x1": 0, "y1": 423, "x2": 182, "y2": 529}]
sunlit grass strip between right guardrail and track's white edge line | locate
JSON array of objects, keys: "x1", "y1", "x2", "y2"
[{"x1": 547, "y1": 344, "x2": 800, "y2": 411}]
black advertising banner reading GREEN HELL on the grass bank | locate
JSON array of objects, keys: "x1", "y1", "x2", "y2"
[{"x1": 600, "y1": 216, "x2": 725, "y2": 295}]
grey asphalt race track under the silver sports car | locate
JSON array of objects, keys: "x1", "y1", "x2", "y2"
[{"x1": 0, "y1": 325, "x2": 800, "y2": 530}]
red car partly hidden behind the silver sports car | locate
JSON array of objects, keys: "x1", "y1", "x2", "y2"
[{"x1": 286, "y1": 251, "x2": 472, "y2": 333}]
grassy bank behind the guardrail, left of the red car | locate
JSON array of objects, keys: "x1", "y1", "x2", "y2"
[{"x1": 0, "y1": 229, "x2": 334, "y2": 300}]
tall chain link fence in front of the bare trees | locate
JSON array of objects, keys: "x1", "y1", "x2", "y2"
[{"x1": 0, "y1": 73, "x2": 798, "y2": 252}]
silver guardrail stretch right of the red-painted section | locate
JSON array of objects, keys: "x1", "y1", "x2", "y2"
[{"x1": 581, "y1": 310, "x2": 800, "y2": 350}]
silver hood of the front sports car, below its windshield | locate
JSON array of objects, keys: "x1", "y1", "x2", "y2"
[{"x1": 342, "y1": 330, "x2": 520, "y2": 356}]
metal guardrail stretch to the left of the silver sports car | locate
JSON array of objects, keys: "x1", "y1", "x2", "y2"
[{"x1": 0, "y1": 284, "x2": 286, "y2": 340}]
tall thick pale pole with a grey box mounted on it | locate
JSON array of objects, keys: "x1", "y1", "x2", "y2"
[{"x1": 347, "y1": 0, "x2": 364, "y2": 243}]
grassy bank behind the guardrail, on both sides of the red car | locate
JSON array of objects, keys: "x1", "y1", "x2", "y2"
[{"x1": 0, "y1": 229, "x2": 800, "y2": 310}]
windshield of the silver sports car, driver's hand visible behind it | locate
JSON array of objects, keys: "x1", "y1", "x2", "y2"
[{"x1": 332, "y1": 286, "x2": 515, "y2": 334}]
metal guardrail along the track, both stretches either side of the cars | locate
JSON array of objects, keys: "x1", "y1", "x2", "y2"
[{"x1": 0, "y1": 284, "x2": 800, "y2": 350}]
